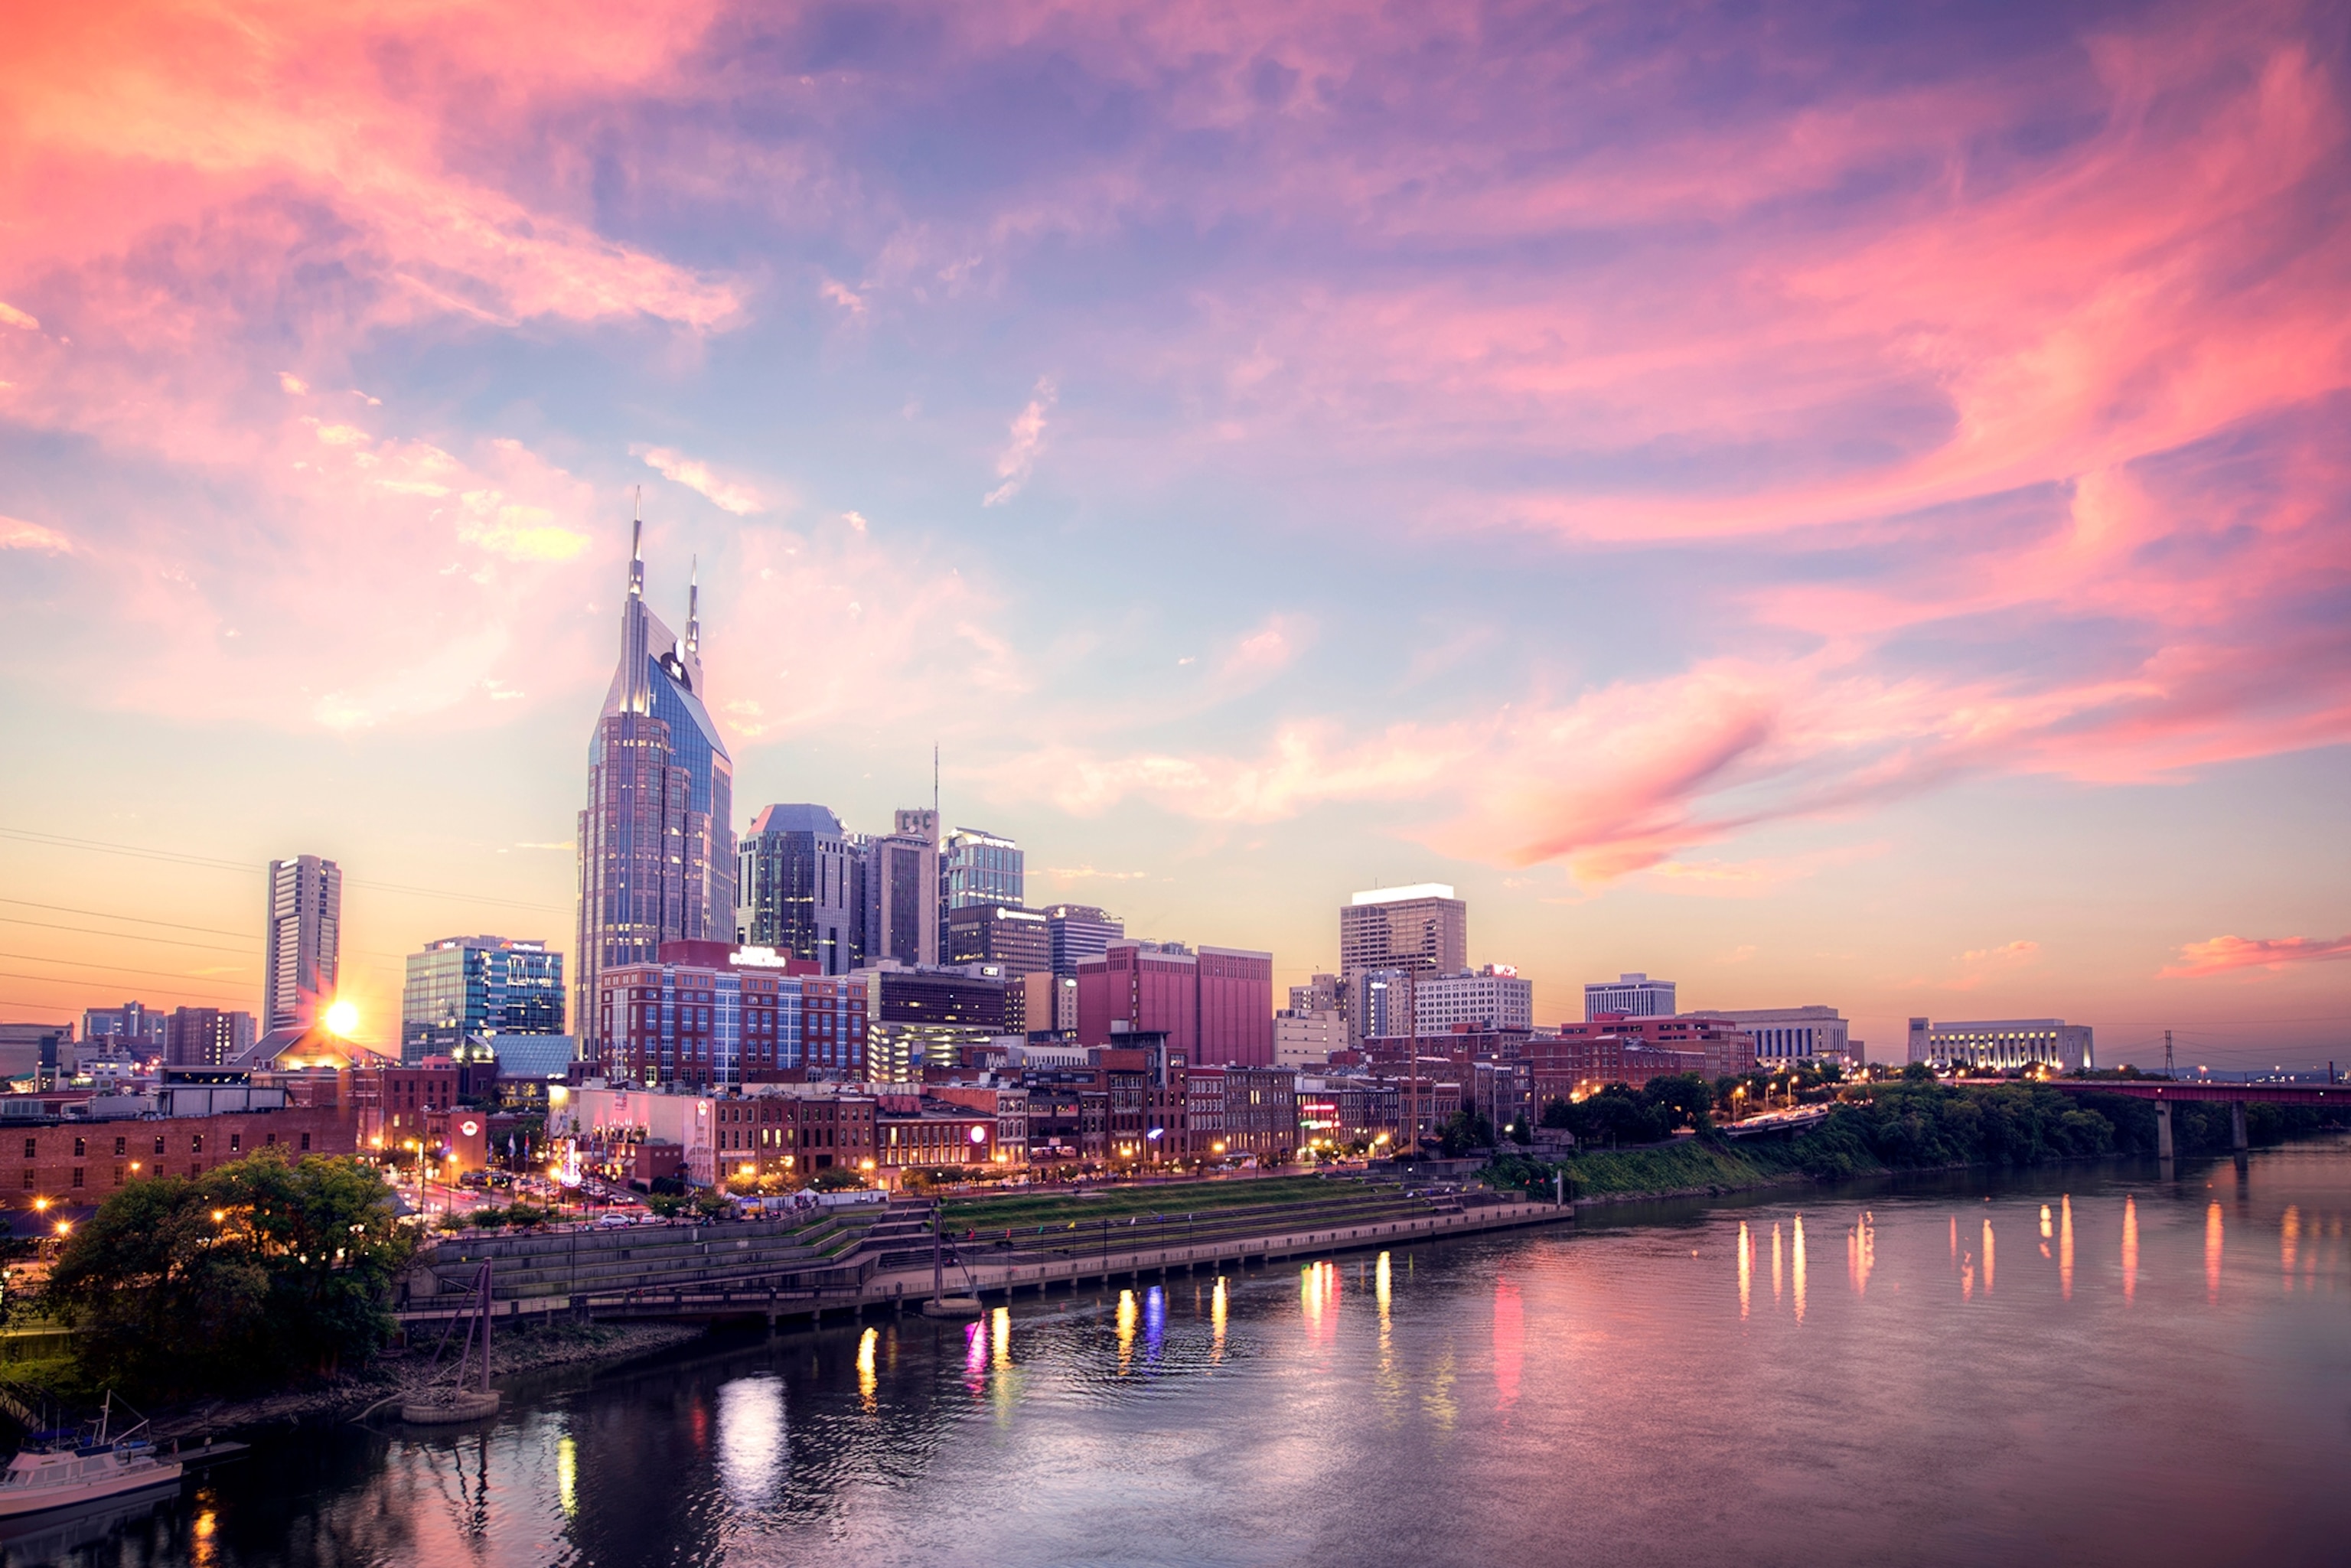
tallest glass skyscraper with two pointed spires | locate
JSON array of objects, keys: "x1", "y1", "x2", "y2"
[{"x1": 571, "y1": 520, "x2": 736, "y2": 1042}]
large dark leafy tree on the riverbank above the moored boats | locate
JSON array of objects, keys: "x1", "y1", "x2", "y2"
[{"x1": 47, "y1": 1149, "x2": 412, "y2": 1397}]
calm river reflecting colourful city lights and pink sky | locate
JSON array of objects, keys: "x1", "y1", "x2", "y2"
[{"x1": 0, "y1": 1143, "x2": 2351, "y2": 1568}]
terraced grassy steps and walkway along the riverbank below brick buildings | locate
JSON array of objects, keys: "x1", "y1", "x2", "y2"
[{"x1": 397, "y1": 1182, "x2": 1573, "y2": 1333}]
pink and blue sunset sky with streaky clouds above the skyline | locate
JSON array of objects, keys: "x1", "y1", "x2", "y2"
[{"x1": 0, "y1": 0, "x2": 2351, "y2": 1068}]
